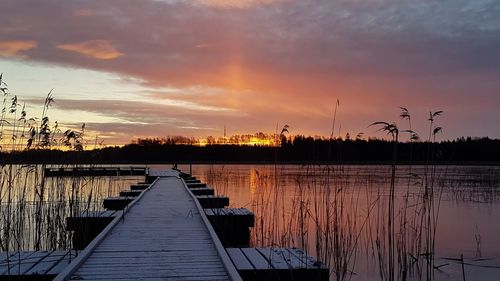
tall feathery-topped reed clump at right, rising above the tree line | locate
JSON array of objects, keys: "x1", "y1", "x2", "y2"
[{"x1": 370, "y1": 107, "x2": 442, "y2": 281}]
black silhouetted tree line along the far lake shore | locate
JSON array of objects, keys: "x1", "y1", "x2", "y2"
[{"x1": 0, "y1": 136, "x2": 500, "y2": 164}]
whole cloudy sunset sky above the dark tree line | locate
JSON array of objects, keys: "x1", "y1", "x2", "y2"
[{"x1": 0, "y1": 0, "x2": 500, "y2": 144}]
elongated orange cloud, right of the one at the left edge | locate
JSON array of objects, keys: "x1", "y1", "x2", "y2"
[{"x1": 57, "y1": 40, "x2": 123, "y2": 60}]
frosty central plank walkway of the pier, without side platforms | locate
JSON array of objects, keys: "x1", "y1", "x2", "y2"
[{"x1": 55, "y1": 171, "x2": 241, "y2": 280}]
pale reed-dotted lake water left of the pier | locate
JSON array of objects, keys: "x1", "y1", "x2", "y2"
[{"x1": 0, "y1": 165, "x2": 143, "y2": 251}]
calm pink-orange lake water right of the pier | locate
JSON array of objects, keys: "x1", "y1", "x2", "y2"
[{"x1": 181, "y1": 165, "x2": 500, "y2": 281}]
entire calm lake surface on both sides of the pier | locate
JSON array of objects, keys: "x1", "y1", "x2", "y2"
[{"x1": 0, "y1": 165, "x2": 500, "y2": 281}]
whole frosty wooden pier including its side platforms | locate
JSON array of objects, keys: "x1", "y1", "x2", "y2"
[{"x1": 0, "y1": 167, "x2": 329, "y2": 281}]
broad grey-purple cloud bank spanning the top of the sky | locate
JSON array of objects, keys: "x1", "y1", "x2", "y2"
[{"x1": 1, "y1": 0, "x2": 500, "y2": 80}]
